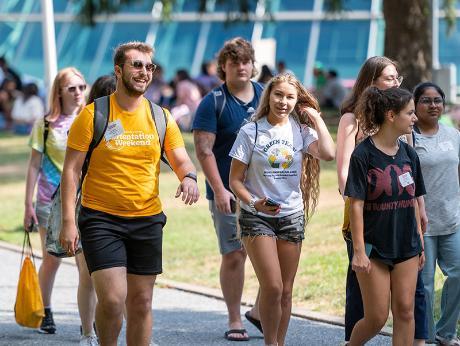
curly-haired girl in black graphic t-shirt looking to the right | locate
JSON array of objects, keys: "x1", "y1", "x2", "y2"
[{"x1": 345, "y1": 87, "x2": 425, "y2": 345}]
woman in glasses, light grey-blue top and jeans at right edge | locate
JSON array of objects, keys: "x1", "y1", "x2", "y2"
[{"x1": 414, "y1": 82, "x2": 460, "y2": 346}]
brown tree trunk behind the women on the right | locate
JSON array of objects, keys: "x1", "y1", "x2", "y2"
[{"x1": 383, "y1": 0, "x2": 433, "y2": 90}]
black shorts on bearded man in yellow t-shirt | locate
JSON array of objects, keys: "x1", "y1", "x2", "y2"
[{"x1": 78, "y1": 206, "x2": 166, "y2": 275}]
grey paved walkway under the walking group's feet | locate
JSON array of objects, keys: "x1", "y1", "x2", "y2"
[{"x1": 0, "y1": 247, "x2": 391, "y2": 346}]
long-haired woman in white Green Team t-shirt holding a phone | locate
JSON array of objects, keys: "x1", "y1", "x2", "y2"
[{"x1": 230, "y1": 74, "x2": 335, "y2": 346}]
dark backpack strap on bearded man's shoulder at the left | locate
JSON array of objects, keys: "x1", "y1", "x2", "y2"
[{"x1": 79, "y1": 96, "x2": 110, "y2": 190}]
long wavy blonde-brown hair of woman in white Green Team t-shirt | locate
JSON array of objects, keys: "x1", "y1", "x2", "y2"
[{"x1": 252, "y1": 73, "x2": 320, "y2": 225}]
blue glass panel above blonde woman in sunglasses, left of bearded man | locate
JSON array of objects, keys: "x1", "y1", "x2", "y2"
[{"x1": 58, "y1": 23, "x2": 107, "y2": 81}]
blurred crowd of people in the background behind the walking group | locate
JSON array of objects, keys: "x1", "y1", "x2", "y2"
[{"x1": 0, "y1": 53, "x2": 460, "y2": 135}]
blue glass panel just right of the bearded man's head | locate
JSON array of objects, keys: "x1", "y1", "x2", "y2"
[{"x1": 155, "y1": 22, "x2": 201, "y2": 79}]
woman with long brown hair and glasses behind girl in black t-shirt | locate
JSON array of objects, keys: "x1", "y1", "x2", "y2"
[{"x1": 336, "y1": 56, "x2": 427, "y2": 345}]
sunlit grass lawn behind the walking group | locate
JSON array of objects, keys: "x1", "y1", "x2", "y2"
[{"x1": 0, "y1": 128, "x2": 452, "y2": 334}]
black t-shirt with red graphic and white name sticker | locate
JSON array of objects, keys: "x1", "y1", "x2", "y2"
[{"x1": 345, "y1": 138, "x2": 425, "y2": 259}]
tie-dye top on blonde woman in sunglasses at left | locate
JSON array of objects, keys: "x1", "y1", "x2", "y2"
[{"x1": 29, "y1": 115, "x2": 75, "y2": 203}]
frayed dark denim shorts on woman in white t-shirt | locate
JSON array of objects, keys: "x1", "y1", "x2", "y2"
[{"x1": 238, "y1": 209, "x2": 305, "y2": 243}]
